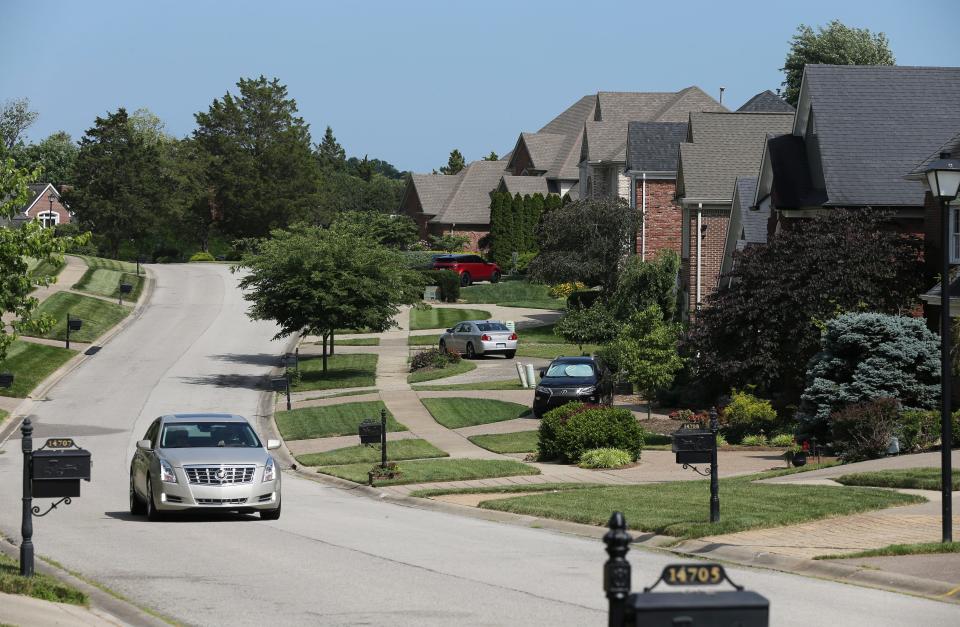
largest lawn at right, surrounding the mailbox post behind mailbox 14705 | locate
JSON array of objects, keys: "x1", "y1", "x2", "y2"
[{"x1": 480, "y1": 473, "x2": 925, "y2": 539}]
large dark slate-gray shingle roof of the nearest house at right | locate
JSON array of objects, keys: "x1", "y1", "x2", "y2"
[{"x1": 804, "y1": 65, "x2": 960, "y2": 206}]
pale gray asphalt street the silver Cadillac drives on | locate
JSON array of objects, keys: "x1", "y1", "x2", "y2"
[{"x1": 0, "y1": 264, "x2": 960, "y2": 626}]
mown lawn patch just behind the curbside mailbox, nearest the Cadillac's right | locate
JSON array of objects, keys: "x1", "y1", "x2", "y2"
[{"x1": 276, "y1": 401, "x2": 407, "y2": 440}]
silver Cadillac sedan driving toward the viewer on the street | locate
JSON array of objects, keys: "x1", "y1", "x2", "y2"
[{"x1": 130, "y1": 414, "x2": 280, "y2": 520}]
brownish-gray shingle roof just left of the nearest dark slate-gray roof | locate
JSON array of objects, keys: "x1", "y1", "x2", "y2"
[{"x1": 677, "y1": 112, "x2": 793, "y2": 202}]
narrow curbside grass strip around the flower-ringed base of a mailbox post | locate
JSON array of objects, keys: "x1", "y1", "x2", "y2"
[{"x1": 317, "y1": 459, "x2": 540, "y2": 485}]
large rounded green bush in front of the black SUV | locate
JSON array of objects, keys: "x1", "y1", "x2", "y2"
[{"x1": 537, "y1": 403, "x2": 643, "y2": 464}]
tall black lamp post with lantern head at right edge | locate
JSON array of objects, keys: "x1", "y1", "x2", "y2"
[{"x1": 921, "y1": 152, "x2": 960, "y2": 542}]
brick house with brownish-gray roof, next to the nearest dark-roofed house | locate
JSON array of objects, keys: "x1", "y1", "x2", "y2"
[{"x1": 677, "y1": 111, "x2": 794, "y2": 313}]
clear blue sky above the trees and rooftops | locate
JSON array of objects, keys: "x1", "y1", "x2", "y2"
[{"x1": 0, "y1": 0, "x2": 960, "y2": 171}]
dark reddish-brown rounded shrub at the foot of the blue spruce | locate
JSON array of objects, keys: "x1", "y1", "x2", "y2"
[{"x1": 830, "y1": 398, "x2": 900, "y2": 462}]
